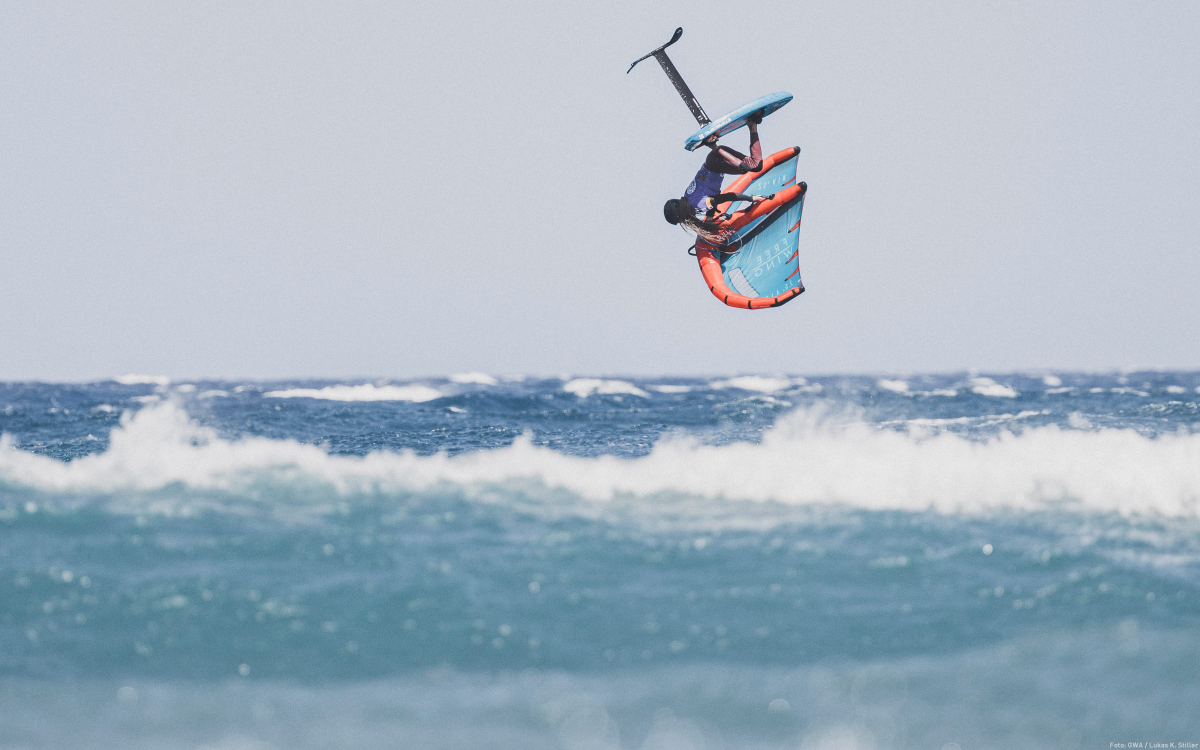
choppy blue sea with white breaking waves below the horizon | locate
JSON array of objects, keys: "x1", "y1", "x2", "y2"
[{"x1": 0, "y1": 372, "x2": 1200, "y2": 750}]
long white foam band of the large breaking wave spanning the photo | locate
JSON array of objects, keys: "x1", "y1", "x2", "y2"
[{"x1": 0, "y1": 402, "x2": 1200, "y2": 516}]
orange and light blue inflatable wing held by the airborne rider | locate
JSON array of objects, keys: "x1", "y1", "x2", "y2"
[{"x1": 696, "y1": 146, "x2": 808, "y2": 310}]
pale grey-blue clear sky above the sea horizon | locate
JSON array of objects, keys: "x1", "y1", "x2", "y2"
[{"x1": 0, "y1": 0, "x2": 1200, "y2": 380}]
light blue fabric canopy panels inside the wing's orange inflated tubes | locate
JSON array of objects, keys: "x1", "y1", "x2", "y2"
[{"x1": 721, "y1": 156, "x2": 804, "y2": 298}]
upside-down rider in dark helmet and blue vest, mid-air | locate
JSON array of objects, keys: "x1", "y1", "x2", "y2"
[{"x1": 662, "y1": 112, "x2": 775, "y2": 245}]
